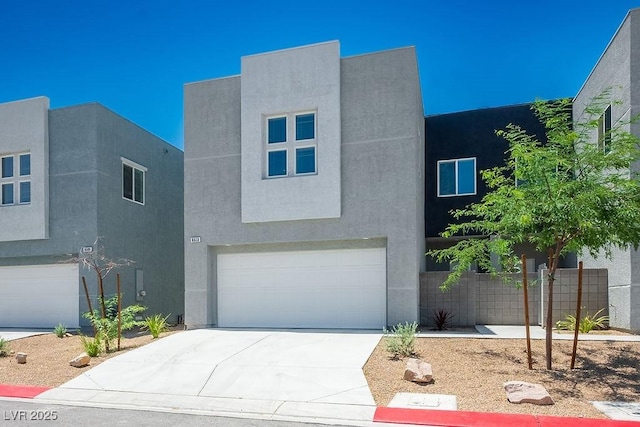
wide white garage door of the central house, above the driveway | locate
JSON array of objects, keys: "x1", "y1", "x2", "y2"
[{"x1": 217, "y1": 248, "x2": 387, "y2": 329}]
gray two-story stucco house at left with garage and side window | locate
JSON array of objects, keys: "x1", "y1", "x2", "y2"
[{"x1": 0, "y1": 97, "x2": 184, "y2": 328}]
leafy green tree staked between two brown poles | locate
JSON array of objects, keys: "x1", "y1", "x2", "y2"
[{"x1": 429, "y1": 91, "x2": 640, "y2": 369}]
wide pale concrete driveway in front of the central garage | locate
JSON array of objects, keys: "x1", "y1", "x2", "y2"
[{"x1": 36, "y1": 329, "x2": 381, "y2": 421}]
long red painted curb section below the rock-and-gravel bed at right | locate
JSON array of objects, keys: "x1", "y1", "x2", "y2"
[{"x1": 373, "y1": 407, "x2": 640, "y2": 427}]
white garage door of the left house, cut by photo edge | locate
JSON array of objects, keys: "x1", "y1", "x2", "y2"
[{"x1": 0, "y1": 264, "x2": 79, "y2": 328}]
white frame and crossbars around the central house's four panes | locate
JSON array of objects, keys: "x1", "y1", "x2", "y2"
[{"x1": 263, "y1": 110, "x2": 318, "y2": 179}]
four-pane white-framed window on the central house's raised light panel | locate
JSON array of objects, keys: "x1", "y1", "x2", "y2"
[{"x1": 265, "y1": 112, "x2": 318, "y2": 178}]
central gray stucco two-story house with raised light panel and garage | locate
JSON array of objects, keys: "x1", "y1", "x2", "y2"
[{"x1": 184, "y1": 42, "x2": 425, "y2": 329}]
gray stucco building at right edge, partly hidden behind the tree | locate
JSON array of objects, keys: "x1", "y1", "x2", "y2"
[{"x1": 573, "y1": 9, "x2": 640, "y2": 331}]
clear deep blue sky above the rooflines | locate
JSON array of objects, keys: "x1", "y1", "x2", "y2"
[{"x1": 0, "y1": 0, "x2": 640, "y2": 148}]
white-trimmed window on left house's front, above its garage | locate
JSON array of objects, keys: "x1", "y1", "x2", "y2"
[{"x1": 0, "y1": 153, "x2": 31, "y2": 206}]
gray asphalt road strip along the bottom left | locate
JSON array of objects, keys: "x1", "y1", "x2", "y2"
[{"x1": 0, "y1": 399, "x2": 356, "y2": 427}]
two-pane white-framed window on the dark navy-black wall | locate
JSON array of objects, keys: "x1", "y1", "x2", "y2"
[{"x1": 438, "y1": 157, "x2": 476, "y2": 197}]
